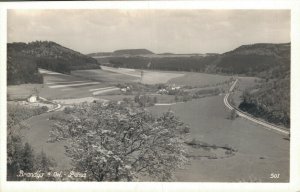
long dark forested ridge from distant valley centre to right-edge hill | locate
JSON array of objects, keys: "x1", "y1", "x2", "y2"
[{"x1": 98, "y1": 43, "x2": 290, "y2": 76}]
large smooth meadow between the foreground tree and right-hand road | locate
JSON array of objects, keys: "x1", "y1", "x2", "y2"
[{"x1": 149, "y1": 96, "x2": 289, "y2": 182}]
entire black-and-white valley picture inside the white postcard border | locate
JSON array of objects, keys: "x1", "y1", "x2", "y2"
[{"x1": 1, "y1": 0, "x2": 300, "y2": 191}]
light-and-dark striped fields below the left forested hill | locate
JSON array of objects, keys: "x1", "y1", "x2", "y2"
[{"x1": 7, "y1": 70, "x2": 122, "y2": 100}]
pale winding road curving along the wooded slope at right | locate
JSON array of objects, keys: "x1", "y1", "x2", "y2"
[{"x1": 224, "y1": 79, "x2": 290, "y2": 136}]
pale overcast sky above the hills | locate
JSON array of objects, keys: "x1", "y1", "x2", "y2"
[{"x1": 7, "y1": 10, "x2": 290, "y2": 53}]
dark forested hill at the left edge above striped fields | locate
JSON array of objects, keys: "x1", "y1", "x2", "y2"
[{"x1": 7, "y1": 41, "x2": 100, "y2": 84}]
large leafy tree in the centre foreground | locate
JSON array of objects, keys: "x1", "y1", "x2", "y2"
[{"x1": 50, "y1": 103, "x2": 186, "y2": 181}]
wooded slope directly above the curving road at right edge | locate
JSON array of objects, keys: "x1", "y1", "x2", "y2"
[{"x1": 239, "y1": 76, "x2": 290, "y2": 127}]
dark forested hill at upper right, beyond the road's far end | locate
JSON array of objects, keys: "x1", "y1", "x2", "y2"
[{"x1": 213, "y1": 43, "x2": 291, "y2": 77}]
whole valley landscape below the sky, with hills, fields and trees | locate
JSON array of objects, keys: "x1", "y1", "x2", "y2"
[{"x1": 7, "y1": 41, "x2": 291, "y2": 182}]
